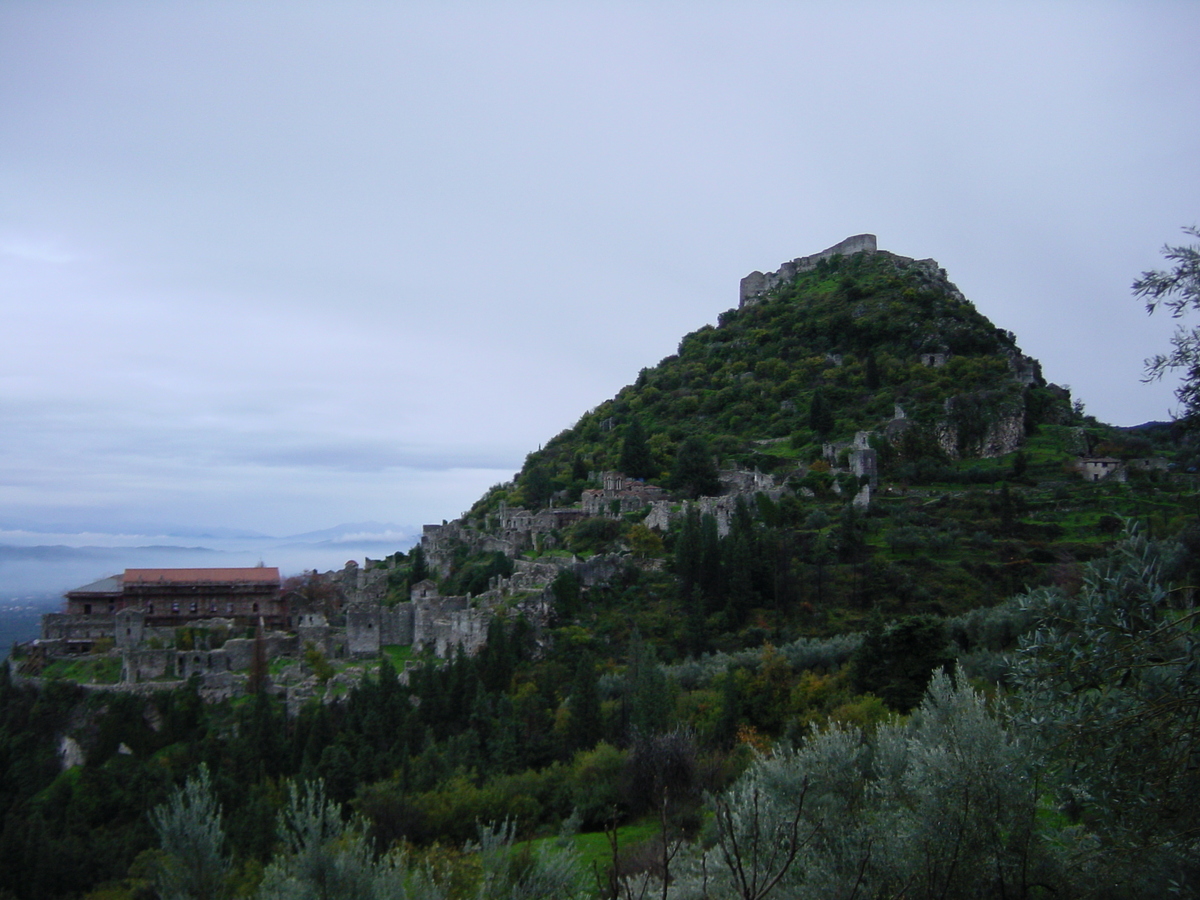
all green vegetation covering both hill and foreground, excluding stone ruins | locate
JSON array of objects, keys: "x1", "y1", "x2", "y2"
[{"x1": 9, "y1": 253, "x2": 1200, "y2": 900}]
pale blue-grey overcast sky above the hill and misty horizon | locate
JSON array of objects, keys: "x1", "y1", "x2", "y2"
[{"x1": 0, "y1": 0, "x2": 1200, "y2": 542}]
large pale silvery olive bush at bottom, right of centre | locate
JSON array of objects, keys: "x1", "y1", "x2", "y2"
[{"x1": 671, "y1": 673, "x2": 1052, "y2": 900}]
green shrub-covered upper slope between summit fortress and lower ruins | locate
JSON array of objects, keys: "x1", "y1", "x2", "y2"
[{"x1": 487, "y1": 252, "x2": 1070, "y2": 511}]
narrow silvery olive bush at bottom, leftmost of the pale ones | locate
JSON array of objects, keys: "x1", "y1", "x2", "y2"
[{"x1": 150, "y1": 766, "x2": 229, "y2": 900}]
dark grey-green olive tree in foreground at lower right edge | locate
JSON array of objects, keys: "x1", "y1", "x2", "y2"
[{"x1": 1015, "y1": 533, "x2": 1200, "y2": 890}]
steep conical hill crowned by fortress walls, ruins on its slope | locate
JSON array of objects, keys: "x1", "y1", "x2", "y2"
[{"x1": 385, "y1": 235, "x2": 1190, "y2": 659}]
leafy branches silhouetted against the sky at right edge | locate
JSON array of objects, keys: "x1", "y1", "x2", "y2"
[{"x1": 1133, "y1": 226, "x2": 1200, "y2": 420}]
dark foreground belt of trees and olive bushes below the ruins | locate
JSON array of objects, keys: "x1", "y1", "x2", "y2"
[{"x1": 0, "y1": 525, "x2": 1200, "y2": 898}]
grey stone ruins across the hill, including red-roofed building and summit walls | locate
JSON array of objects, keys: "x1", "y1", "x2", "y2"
[{"x1": 22, "y1": 234, "x2": 1089, "y2": 703}]
